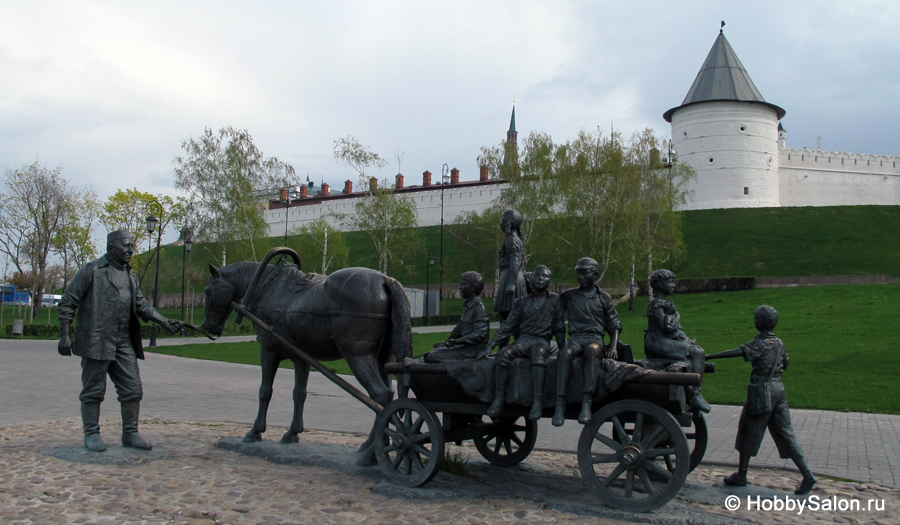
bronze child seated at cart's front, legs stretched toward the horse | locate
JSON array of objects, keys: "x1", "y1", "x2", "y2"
[{"x1": 425, "y1": 272, "x2": 490, "y2": 363}]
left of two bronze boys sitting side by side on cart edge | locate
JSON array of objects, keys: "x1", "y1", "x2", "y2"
[{"x1": 487, "y1": 265, "x2": 566, "y2": 421}]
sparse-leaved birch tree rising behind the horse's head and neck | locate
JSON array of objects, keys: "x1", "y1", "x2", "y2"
[{"x1": 173, "y1": 127, "x2": 299, "y2": 266}]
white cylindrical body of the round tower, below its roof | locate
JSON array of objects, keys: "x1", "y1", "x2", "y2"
[{"x1": 672, "y1": 101, "x2": 780, "y2": 210}]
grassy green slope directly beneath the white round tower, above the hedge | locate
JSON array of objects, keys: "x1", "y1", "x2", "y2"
[{"x1": 674, "y1": 206, "x2": 900, "y2": 278}]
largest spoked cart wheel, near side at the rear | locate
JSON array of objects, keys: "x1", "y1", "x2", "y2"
[{"x1": 578, "y1": 400, "x2": 690, "y2": 512}]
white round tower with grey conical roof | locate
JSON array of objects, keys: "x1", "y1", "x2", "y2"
[{"x1": 663, "y1": 31, "x2": 785, "y2": 209}]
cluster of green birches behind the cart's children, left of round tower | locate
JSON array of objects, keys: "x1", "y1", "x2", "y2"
[{"x1": 468, "y1": 129, "x2": 692, "y2": 280}]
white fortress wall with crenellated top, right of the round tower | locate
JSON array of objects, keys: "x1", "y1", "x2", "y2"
[{"x1": 779, "y1": 148, "x2": 900, "y2": 206}]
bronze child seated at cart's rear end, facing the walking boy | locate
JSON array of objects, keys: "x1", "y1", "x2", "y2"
[{"x1": 644, "y1": 270, "x2": 710, "y2": 412}]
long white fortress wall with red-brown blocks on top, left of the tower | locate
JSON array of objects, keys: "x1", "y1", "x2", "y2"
[{"x1": 264, "y1": 183, "x2": 507, "y2": 237}]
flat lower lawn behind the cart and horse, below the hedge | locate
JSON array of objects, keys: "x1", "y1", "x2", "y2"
[{"x1": 157, "y1": 284, "x2": 900, "y2": 414}]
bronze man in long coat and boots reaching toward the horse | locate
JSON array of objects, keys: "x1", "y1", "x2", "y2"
[{"x1": 59, "y1": 230, "x2": 182, "y2": 452}]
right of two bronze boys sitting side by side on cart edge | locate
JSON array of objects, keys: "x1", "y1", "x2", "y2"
[{"x1": 553, "y1": 257, "x2": 622, "y2": 427}]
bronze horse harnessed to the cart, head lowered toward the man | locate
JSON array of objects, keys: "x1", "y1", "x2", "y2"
[{"x1": 203, "y1": 249, "x2": 412, "y2": 464}]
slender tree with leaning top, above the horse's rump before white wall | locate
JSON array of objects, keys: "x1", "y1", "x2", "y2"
[{"x1": 334, "y1": 135, "x2": 420, "y2": 274}]
